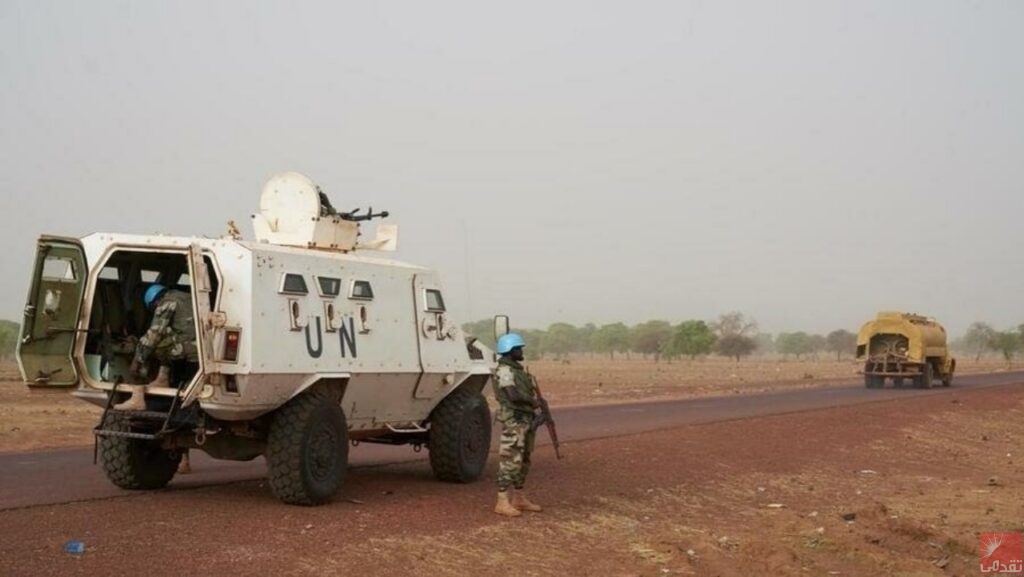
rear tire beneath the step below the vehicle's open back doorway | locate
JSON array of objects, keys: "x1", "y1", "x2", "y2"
[{"x1": 99, "y1": 415, "x2": 181, "y2": 490}]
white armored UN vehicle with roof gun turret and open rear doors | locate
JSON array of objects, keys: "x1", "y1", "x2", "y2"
[{"x1": 17, "y1": 172, "x2": 494, "y2": 504}]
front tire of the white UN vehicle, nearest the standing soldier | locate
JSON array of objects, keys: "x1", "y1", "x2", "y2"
[{"x1": 428, "y1": 389, "x2": 490, "y2": 483}]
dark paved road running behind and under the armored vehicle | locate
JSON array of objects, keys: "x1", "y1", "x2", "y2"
[{"x1": 0, "y1": 372, "x2": 1024, "y2": 511}]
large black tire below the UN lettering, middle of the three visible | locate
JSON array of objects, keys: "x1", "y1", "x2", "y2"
[{"x1": 266, "y1": 394, "x2": 348, "y2": 505}]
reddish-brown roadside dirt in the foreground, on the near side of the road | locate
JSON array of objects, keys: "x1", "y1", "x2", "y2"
[{"x1": 0, "y1": 377, "x2": 1024, "y2": 577}]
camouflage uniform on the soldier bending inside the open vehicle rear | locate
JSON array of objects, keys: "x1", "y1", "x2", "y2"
[{"x1": 135, "y1": 289, "x2": 199, "y2": 367}]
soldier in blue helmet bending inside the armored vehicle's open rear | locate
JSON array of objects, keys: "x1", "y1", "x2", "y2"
[{"x1": 114, "y1": 284, "x2": 199, "y2": 411}]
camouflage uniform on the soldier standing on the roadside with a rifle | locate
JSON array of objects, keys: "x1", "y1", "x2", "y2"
[{"x1": 494, "y1": 357, "x2": 537, "y2": 491}]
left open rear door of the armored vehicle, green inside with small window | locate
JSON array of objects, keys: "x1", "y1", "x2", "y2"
[{"x1": 17, "y1": 237, "x2": 89, "y2": 387}]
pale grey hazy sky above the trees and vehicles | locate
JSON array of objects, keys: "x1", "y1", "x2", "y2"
[{"x1": 0, "y1": 0, "x2": 1024, "y2": 332}]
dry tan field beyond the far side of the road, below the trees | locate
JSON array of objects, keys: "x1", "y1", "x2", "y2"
[{"x1": 0, "y1": 357, "x2": 1006, "y2": 452}]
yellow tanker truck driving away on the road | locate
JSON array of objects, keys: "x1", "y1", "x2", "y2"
[{"x1": 857, "y1": 312, "x2": 956, "y2": 388}]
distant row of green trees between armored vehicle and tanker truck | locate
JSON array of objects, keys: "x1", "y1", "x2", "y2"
[{"x1": 463, "y1": 312, "x2": 857, "y2": 362}]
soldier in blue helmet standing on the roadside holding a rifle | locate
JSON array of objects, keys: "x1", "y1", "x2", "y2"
[{"x1": 494, "y1": 333, "x2": 543, "y2": 517}]
